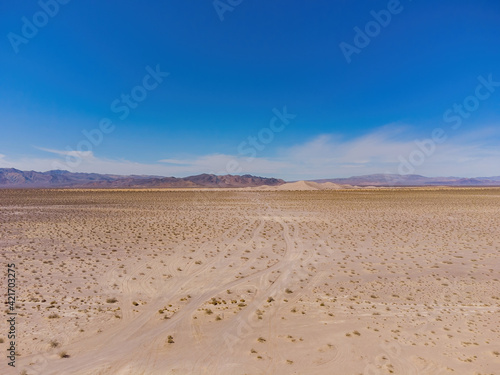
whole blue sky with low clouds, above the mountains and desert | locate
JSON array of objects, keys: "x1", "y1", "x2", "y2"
[{"x1": 0, "y1": 0, "x2": 500, "y2": 180}]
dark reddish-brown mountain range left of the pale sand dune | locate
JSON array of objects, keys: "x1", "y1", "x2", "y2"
[{"x1": 0, "y1": 168, "x2": 285, "y2": 188}]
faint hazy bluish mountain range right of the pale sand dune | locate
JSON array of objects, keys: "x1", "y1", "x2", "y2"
[{"x1": 313, "y1": 174, "x2": 500, "y2": 186}]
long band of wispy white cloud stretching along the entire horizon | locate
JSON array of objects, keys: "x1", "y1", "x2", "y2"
[{"x1": 0, "y1": 124, "x2": 500, "y2": 180}]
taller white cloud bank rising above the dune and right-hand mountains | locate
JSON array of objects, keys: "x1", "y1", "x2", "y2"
[{"x1": 282, "y1": 127, "x2": 500, "y2": 178}]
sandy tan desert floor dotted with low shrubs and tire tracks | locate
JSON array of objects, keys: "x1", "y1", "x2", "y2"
[{"x1": 0, "y1": 188, "x2": 500, "y2": 375}]
